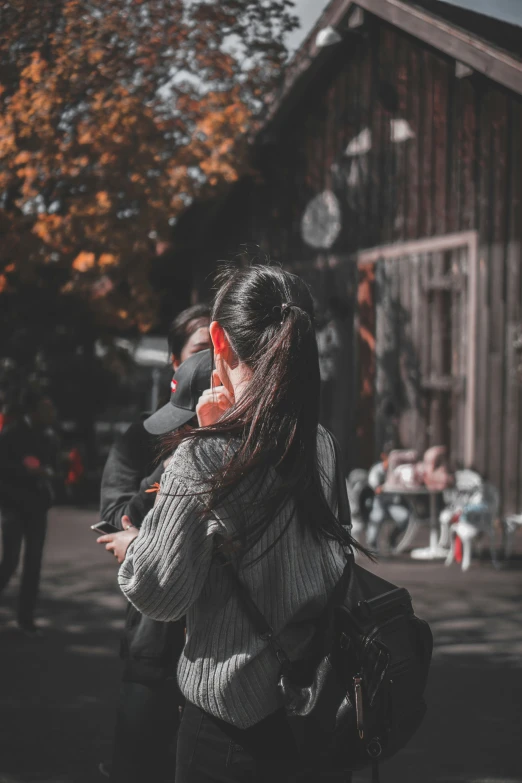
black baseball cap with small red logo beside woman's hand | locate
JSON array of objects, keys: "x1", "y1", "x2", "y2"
[{"x1": 143, "y1": 350, "x2": 212, "y2": 435}]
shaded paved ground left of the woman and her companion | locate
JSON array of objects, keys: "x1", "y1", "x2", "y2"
[{"x1": 0, "y1": 509, "x2": 125, "y2": 783}]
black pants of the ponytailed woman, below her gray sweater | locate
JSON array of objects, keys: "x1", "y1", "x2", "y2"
[{"x1": 176, "y1": 702, "x2": 351, "y2": 783}]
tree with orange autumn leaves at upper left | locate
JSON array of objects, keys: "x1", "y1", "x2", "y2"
[{"x1": 0, "y1": 0, "x2": 296, "y2": 331}]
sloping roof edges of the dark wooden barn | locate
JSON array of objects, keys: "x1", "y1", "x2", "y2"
[{"x1": 264, "y1": 0, "x2": 522, "y2": 136}]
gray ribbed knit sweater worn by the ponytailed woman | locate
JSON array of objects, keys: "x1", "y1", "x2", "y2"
[{"x1": 119, "y1": 427, "x2": 345, "y2": 728}]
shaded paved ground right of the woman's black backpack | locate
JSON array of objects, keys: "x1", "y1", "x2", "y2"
[{"x1": 354, "y1": 557, "x2": 522, "y2": 783}]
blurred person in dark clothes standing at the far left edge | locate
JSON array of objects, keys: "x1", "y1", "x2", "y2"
[{"x1": 0, "y1": 390, "x2": 59, "y2": 636}]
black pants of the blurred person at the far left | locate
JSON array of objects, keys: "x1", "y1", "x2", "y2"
[{"x1": 0, "y1": 509, "x2": 47, "y2": 625}]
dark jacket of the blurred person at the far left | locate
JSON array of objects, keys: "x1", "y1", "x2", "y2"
[{"x1": 0, "y1": 419, "x2": 58, "y2": 514}]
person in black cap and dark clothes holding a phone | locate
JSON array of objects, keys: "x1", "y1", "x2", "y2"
[{"x1": 98, "y1": 350, "x2": 212, "y2": 783}]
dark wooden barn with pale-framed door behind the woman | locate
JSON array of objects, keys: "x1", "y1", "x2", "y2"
[{"x1": 177, "y1": 0, "x2": 522, "y2": 511}]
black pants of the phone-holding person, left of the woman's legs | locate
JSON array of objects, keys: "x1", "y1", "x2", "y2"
[{"x1": 111, "y1": 677, "x2": 180, "y2": 783}]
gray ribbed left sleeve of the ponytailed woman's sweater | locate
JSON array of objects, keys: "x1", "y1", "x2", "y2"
[{"x1": 118, "y1": 464, "x2": 219, "y2": 621}]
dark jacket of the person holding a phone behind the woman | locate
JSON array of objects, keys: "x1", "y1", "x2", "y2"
[{"x1": 100, "y1": 415, "x2": 185, "y2": 683}]
